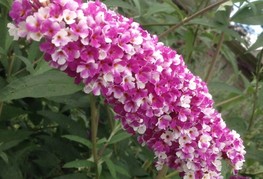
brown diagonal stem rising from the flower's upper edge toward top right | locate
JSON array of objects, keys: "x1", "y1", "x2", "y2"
[{"x1": 159, "y1": 0, "x2": 229, "y2": 38}]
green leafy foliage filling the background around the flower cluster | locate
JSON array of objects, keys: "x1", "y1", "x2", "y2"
[{"x1": 0, "y1": 0, "x2": 263, "y2": 179}]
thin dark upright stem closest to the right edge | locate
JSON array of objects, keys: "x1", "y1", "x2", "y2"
[{"x1": 247, "y1": 49, "x2": 263, "y2": 131}]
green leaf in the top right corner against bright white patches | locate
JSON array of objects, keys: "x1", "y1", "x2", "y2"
[{"x1": 231, "y1": 0, "x2": 263, "y2": 25}]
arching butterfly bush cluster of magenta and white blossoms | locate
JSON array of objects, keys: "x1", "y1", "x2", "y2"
[{"x1": 8, "y1": 0, "x2": 248, "y2": 179}]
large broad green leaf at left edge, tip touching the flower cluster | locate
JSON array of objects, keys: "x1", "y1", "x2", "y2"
[{"x1": 0, "y1": 70, "x2": 82, "y2": 102}]
